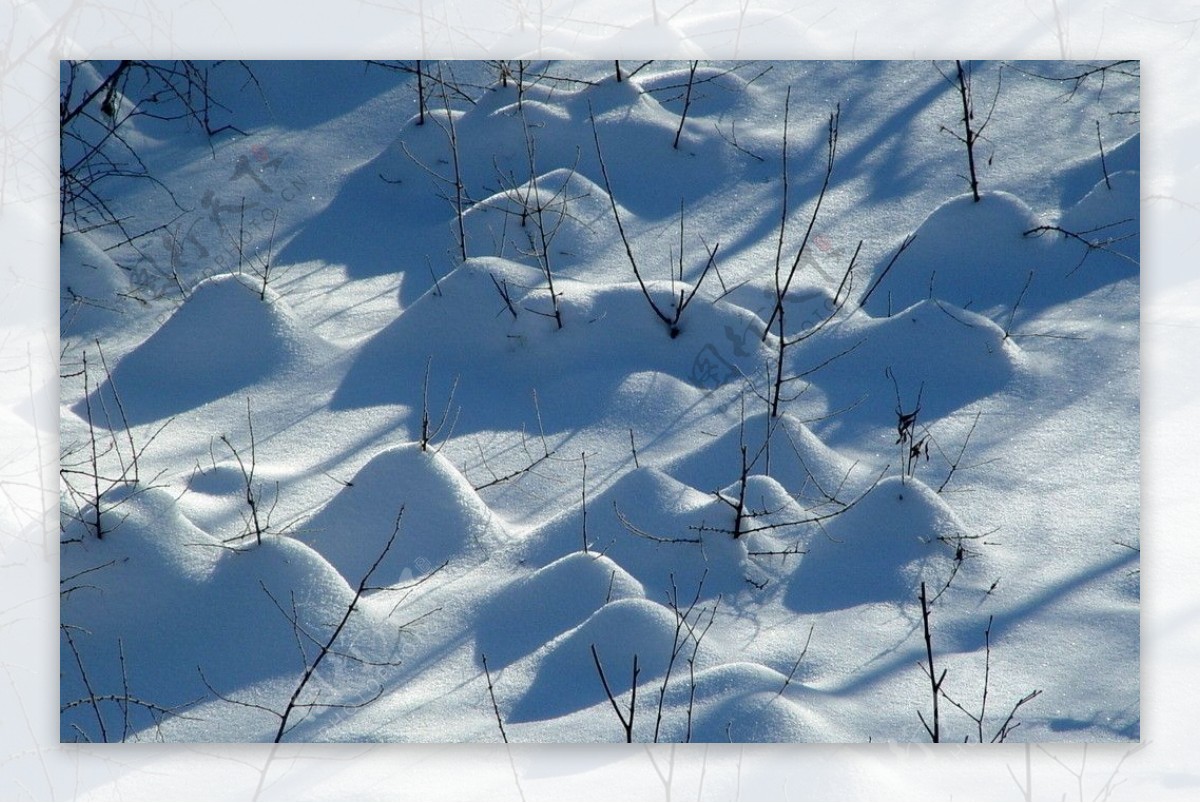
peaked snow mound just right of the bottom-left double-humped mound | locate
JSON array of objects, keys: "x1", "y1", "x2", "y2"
[{"x1": 296, "y1": 443, "x2": 504, "y2": 586}]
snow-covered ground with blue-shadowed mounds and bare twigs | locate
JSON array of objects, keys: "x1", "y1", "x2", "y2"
[{"x1": 60, "y1": 61, "x2": 1141, "y2": 742}]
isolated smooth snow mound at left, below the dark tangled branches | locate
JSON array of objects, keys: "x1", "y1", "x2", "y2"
[{"x1": 82, "y1": 275, "x2": 325, "y2": 424}]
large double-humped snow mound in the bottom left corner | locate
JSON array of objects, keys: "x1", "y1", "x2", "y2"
[{"x1": 61, "y1": 487, "x2": 376, "y2": 738}]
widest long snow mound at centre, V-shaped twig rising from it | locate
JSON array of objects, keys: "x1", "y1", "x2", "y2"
[{"x1": 331, "y1": 258, "x2": 762, "y2": 417}]
